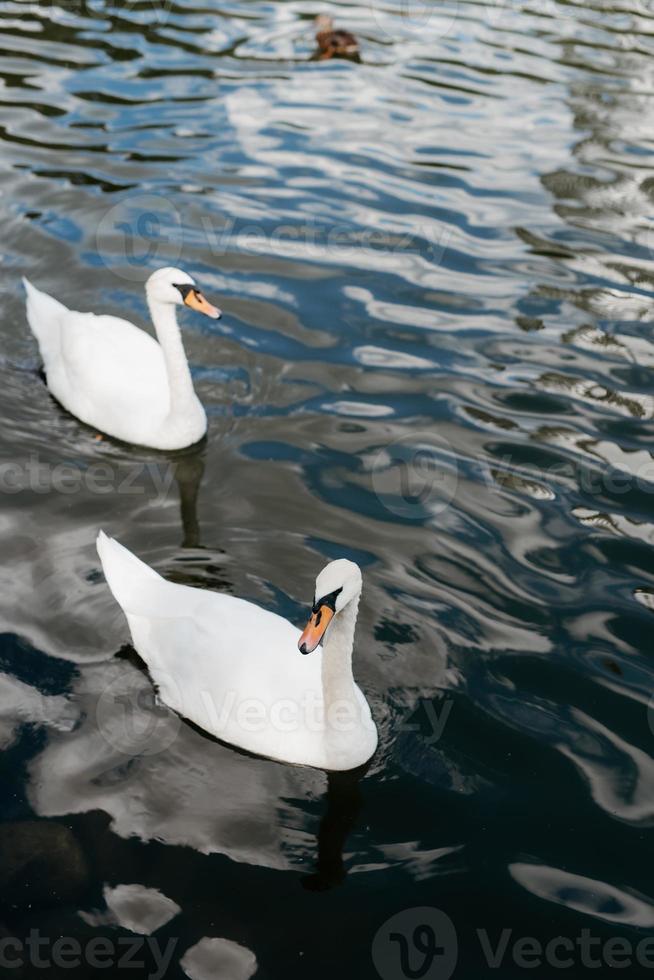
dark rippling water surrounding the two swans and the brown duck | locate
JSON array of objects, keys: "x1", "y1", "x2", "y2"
[{"x1": 0, "y1": 0, "x2": 654, "y2": 980}]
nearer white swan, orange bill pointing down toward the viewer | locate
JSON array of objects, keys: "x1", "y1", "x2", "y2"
[{"x1": 97, "y1": 532, "x2": 377, "y2": 770}]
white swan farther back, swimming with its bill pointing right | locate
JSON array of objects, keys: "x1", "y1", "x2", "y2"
[{"x1": 23, "y1": 268, "x2": 221, "y2": 449}]
